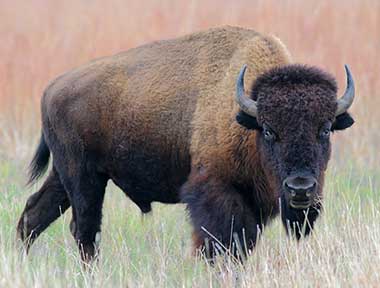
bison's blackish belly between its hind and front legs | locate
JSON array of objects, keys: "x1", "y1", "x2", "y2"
[{"x1": 110, "y1": 146, "x2": 190, "y2": 211}]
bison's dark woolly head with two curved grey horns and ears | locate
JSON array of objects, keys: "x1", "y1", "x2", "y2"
[{"x1": 236, "y1": 65, "x2": 354, "y2": 209}]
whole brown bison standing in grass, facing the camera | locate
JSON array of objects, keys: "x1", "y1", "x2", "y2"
[{"x1": 17, "y1": 27, "x2": 354, "y2": 261}]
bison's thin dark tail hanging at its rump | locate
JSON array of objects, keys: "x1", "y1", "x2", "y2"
[{"x1": 28, "y1": 133, "x2": 50, "y2": 184}]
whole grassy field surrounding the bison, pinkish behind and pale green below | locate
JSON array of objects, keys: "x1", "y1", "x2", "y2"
[{"x1": 0, "y1": 0, "x2": 380, "y2": 287}]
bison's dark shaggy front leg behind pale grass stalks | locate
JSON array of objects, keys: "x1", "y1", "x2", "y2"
[{"x1": 181, "y1": 173, "x2": 257, "y2": 260}]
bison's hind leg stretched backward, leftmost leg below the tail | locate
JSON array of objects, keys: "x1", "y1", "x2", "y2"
[{"x1": 17, "y1": 168, "x2": 70, "y2": 251}]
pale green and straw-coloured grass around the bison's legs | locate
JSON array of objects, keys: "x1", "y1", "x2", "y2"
[{"x1": 0, "y1": 160, "x2": 380, "y2": 287}]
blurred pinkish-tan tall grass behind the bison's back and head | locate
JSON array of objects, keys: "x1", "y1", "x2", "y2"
[{"x1": 0, "y1": 0, "x2": 380, "y2": 171}]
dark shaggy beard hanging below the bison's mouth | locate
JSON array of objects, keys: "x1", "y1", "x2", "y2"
[{"x1": 281, "y1": 197, "x2": 321, "y2": 239}]
